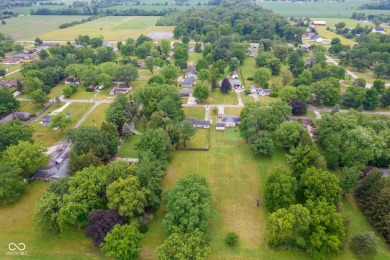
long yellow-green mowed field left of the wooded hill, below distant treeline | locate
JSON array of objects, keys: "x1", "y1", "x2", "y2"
[{"x1": 39, "y1": 16, "x2": 174, "y2": 41}]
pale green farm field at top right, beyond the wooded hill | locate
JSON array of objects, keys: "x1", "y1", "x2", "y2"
[{"x1": 256, "y1": 0, "x2": 383, "y2": 18}]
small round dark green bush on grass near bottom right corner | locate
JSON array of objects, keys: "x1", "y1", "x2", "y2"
[{"x1": 350, "y1": 231, "x2": 379, "y2": 256}]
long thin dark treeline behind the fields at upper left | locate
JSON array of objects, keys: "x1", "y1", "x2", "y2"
[{"x1": 31, "y1": 8, "x2": 176, "y2": 16}]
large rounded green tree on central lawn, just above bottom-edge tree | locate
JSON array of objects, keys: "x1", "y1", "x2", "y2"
[{"x1": 163, "y1": 175, "x2": 212, "y2": 234}]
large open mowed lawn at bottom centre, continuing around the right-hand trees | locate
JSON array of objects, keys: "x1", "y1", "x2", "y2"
[{"x1": 140, "y1": 120, "x2": 390, "y2": 260}]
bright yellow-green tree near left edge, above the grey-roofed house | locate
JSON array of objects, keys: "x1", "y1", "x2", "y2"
[{"x1": 2, "y1": 141, "x2": 49, "y2": 177}]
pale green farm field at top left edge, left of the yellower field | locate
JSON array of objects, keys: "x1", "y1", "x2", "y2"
[{"x1": 1, "y1": 15, "x2": 86, "y2": 41}]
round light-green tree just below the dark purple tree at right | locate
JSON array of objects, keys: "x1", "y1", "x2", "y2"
[{"x1": 275, "y1": 121, "x2": 306, "y2": 148}]
